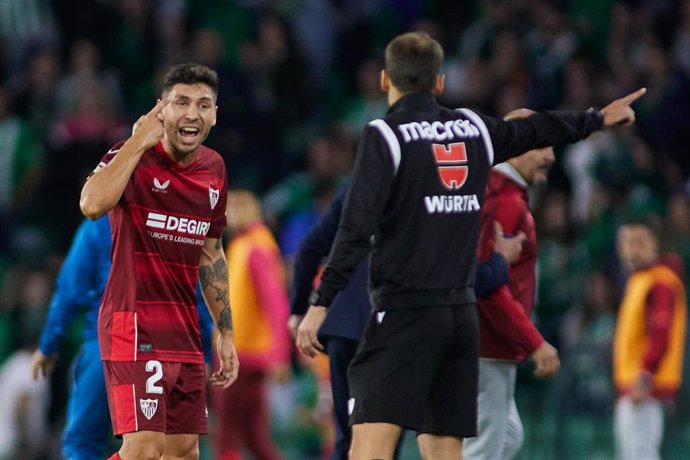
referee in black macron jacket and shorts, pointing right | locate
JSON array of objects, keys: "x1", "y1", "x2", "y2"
[{"x1": 296, "y1": 33, "x2": 645, "y2": 460}]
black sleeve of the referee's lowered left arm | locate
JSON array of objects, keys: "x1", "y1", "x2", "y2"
[{"x1": 317, "y1": 126, "x2": 395, "y2": 307}]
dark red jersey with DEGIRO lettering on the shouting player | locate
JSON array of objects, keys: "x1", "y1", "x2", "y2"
[{"x1": 98, "y1": 143, "x2": 227, "y2": 363}]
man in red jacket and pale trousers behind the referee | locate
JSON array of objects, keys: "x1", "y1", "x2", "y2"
[{"x1": 463, "y1": 109, "x2": 560, "y2": 460}]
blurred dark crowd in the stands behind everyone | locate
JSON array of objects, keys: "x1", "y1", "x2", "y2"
[{"x1": 0, "y1": 0, "x2": 690, "y2": 459}]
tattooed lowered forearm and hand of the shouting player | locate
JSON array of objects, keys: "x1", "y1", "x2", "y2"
[{"x1": 199, "y1": 238, "x2": 240, "y2": 388}]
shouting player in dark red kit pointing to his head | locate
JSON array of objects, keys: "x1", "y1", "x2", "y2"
[{"x1": 80, "y1": 64, "x2": 239, "y2": 460}]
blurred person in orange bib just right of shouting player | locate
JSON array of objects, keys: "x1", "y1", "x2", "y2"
[{"x1": 212, "y1": 190, "x2": 291, "y2": 460}]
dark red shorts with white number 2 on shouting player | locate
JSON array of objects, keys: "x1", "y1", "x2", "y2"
[{"x1": 103, "y1": 360, "x2": 208, "y2": 435}]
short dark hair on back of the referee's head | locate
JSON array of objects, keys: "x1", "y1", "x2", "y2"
[{"x1": 386, "y1": 32, "x2": 443, "y2": 93}]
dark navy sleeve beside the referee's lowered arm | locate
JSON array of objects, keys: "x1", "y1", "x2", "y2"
[{"x1": 290, "y1": 187, "x2": 347, "y2": 315}]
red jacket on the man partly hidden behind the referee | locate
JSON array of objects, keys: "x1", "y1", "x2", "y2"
[{"x1": 477, "y1": 163, "x2": 544, "y2": 361}]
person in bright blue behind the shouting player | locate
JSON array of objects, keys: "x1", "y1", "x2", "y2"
[{"x1": 33, "y1": 215, "x2": 213, "y2": 460}]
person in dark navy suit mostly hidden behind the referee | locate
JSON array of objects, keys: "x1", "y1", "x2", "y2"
[{"x1": 288, "y1": 186, "x2": 525, "y2": 460}]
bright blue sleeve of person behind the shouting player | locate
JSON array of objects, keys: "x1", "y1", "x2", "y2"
[{"x1": 39, "y1": 220, "x2": 98, "y2": 355}]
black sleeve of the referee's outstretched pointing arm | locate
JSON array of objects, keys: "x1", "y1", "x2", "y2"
[{"x1": 481, "y1": 110, "x2": 604, "y2": 164}]
